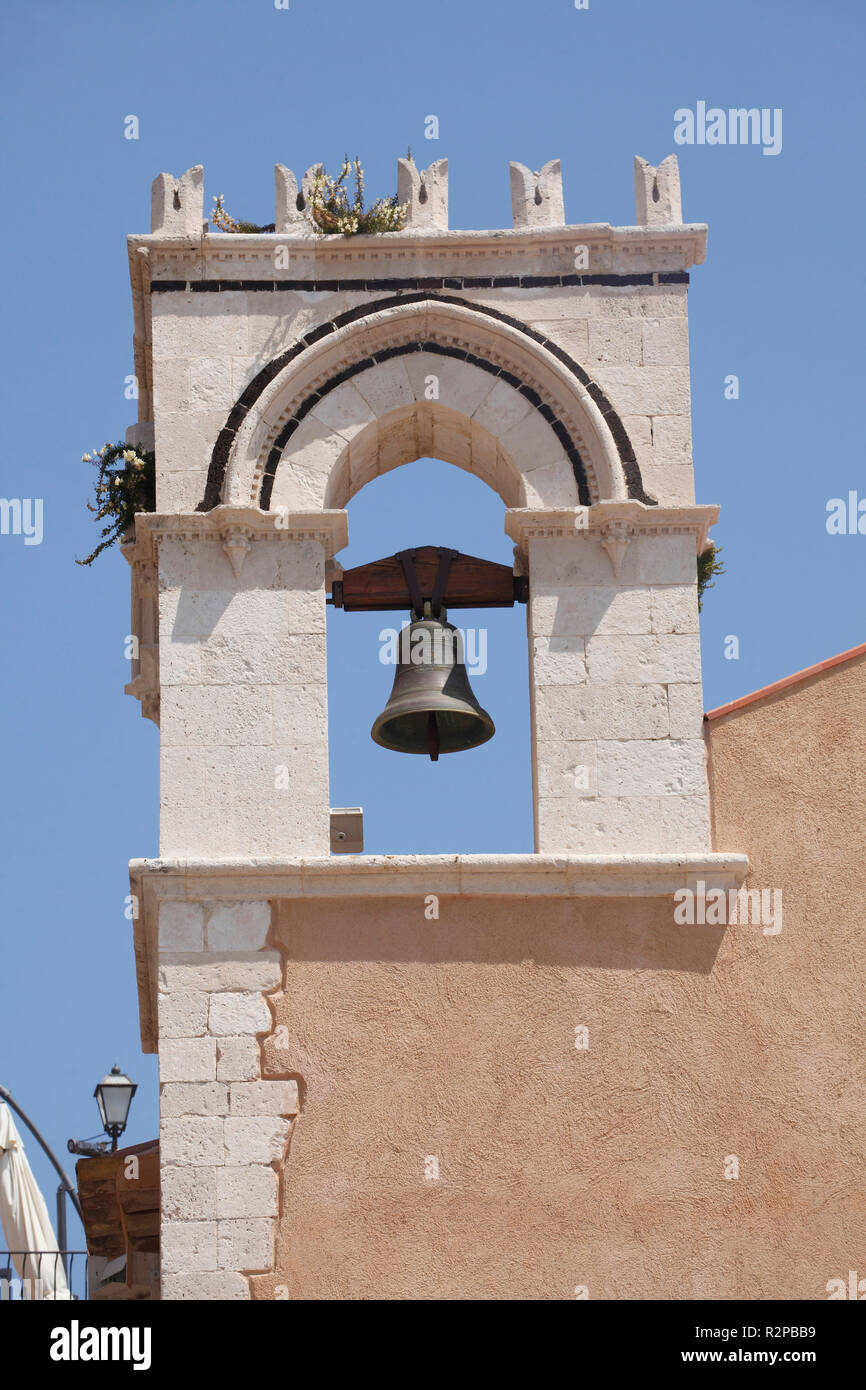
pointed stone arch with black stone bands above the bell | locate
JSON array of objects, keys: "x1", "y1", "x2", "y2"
[{"x1": 200, "y1": 293, "x2": 655, "y2": 510}]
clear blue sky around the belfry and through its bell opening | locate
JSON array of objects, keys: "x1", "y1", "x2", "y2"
[{"x1": 0, "y1": 0, "x2": 866, "y2": 1256}]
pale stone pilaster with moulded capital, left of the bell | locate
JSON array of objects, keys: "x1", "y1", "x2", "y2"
[{"x1": 129, "y1": 507, "x2": 346, "y2": 856}]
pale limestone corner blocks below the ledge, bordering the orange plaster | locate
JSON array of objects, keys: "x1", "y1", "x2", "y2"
[{"x1": 158, "y1": 902, "x2": 299, "y2": 1298}]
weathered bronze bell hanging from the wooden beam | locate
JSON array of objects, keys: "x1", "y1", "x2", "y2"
[{"x1": 370, "y1": 617, "x2": 496, "y2": 763}]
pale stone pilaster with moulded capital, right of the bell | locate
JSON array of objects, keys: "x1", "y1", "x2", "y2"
[{"x1": 507, "y1": 503, "x2": 714, "y2": 853}]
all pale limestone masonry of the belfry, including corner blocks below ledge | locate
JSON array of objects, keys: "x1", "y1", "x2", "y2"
[{"x1": 122, "y1": 156, "x2": 745, "y2": 1298}]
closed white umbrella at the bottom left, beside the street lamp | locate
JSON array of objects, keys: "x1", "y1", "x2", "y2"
[{"x1": 0, "y1": 1101, "x2": 72, "y2": 1300}]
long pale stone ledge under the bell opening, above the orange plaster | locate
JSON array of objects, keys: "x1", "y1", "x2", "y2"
[{"x1": 129, "y1": 851, "x2": 749, "y2": 1052}]
